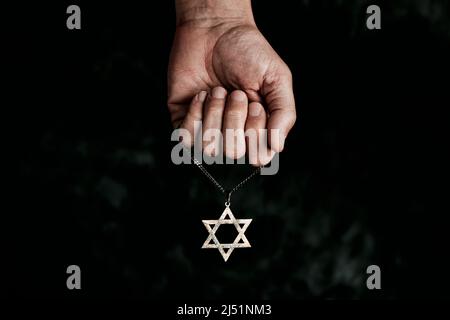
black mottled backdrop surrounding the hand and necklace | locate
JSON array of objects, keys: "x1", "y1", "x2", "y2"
[{"x1": 6, "y1": 0, "x2": 450, "y2": 301}]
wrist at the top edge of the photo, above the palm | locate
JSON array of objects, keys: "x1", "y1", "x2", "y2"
[{"x1": 175, "y1": 0, "x2": 255, "y2": 28}]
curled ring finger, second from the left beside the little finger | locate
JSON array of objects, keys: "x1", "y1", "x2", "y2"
[{"x1": 203, "y1": 87, "x2": 227, "y2": 157}]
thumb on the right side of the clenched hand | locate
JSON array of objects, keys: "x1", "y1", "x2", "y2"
[{"x1": 263, "y1": 67, "x2": 296, "y2": 152}]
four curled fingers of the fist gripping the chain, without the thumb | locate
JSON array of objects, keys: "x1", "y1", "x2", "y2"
[{"x1": 180, "y1": 87, "x2": 275, "y2": 166}]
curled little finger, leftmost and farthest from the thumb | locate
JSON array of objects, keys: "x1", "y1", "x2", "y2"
[{"x1": 180, "y1": 91, "x2": 207, "y2": 147}]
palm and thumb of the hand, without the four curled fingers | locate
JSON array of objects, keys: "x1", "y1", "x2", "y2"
[{"x1": 168, "y1": 22, "x2": 296, "y2": 159}]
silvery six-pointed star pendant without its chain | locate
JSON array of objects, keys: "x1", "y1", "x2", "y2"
[{"x1": 202, "y1": 207, "x2": 252, "y2": 261}]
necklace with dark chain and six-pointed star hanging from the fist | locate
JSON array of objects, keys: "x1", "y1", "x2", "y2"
[{"x1": 192, "y1": 157, "x2": 262, "y2": 262}]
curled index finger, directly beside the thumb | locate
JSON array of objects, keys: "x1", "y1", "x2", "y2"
[{"x1": 245, "y1": 102, "x2": 275, "y2": 167}]
